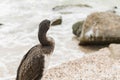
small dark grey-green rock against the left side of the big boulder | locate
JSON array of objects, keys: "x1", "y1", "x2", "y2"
[{"x1": 72, "y1": 21, "x2": 84, "y2": 37}]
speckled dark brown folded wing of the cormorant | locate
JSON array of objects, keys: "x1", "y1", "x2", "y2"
[{"x1": 18, "y1": 45, "x2": 44, "y2": 80}]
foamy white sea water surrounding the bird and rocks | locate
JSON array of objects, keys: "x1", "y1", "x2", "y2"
[{"x1": 0, "y1": 0, "x2": 120, "y2": 80}]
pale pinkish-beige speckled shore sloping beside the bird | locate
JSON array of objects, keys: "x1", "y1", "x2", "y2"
[{"x1": 42, "y1": 47, "x2": 120, "y2": 80}]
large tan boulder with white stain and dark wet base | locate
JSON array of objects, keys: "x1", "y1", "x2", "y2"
[{"x1": 79, "y1": 12, "x2": 120, "y2": 44}]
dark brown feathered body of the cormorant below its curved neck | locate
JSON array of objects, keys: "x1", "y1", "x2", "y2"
[{"x1": 16, "y1": 45, "x2": 54, "y2": 80}]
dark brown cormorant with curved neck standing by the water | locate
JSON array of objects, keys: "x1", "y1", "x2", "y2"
[{"x1": 16, "y1": 20, "x2": 55, "y2": 80}]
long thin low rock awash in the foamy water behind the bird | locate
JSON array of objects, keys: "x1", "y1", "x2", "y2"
[{"x1": 52, "y1": 4, "x2": 92, "y2": 11}]
